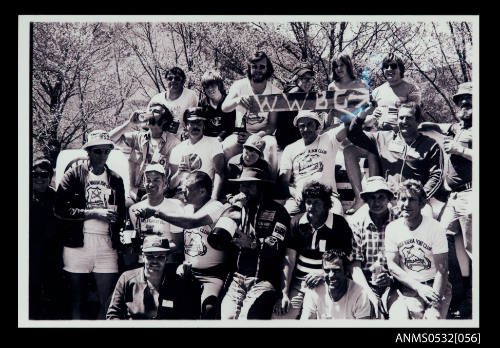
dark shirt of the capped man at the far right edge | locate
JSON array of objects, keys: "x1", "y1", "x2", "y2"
[{"x1": 446, "y1": 123, "x2": 472, "y2": 190}]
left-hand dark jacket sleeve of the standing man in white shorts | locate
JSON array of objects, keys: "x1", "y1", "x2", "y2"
[{"x1": 54, "y1": 166, "x2": 85, "y2": 220}]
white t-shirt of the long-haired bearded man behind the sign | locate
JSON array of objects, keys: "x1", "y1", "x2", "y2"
[{"x1": 228, "y1": 78, "x2": 281, "y2": 133}]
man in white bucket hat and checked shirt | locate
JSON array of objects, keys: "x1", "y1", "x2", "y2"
[{"x1": 348, "y1": 176, "x2": 395, "y2": 318}]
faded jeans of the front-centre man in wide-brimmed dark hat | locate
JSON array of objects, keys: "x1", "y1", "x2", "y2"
[{"x1": 221, "y1": 273, "x2": 277, "y2": 319}]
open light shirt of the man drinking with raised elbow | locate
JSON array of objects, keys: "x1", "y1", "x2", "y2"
[{"x1": 119, "y1": 131, "x2": 180, "y2": 189}]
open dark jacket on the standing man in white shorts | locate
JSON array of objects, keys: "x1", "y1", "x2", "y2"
[{"x1": 55, "y1": 163, "x2": 126, "y2": 249}]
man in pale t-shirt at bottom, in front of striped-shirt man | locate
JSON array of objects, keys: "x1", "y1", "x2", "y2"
[{"x1": 300, "y1": 249, "x2": 370, "y2": 320}]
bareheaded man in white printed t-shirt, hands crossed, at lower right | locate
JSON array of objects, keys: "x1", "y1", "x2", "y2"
[{"x1": 385, "y1": 179, "x2": 451, "y2": 320}]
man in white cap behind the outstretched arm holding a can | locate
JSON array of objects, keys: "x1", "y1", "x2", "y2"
[{"x1": 129, "y1": 163, "x2": 184, "y2": 264}]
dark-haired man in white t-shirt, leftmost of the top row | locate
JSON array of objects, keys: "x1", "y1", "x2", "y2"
[{"x1": 148, "y1": 67, "x2": 198, "y2": 140}]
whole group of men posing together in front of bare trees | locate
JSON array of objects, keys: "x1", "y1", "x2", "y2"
[{"x1": 30, "y1": 51, "x2": 472, "y2": 320}]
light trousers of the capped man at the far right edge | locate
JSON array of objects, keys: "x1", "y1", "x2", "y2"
[{"x1": 441, "y1": 190, "x2": 472, "y2": 258}]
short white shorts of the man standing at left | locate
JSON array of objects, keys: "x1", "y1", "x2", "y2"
[{"x1": 63, "y1": 233, "x2": 118, "y2": 273}]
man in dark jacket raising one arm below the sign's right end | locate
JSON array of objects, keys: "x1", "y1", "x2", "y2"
[{"x1": 346, "y1": 103, "x2": 443, "y2": 216}]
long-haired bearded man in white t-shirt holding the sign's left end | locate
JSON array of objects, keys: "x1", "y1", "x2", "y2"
[{"x1": 222, "y1": 51, "x2": 281, "y2": 175}]
